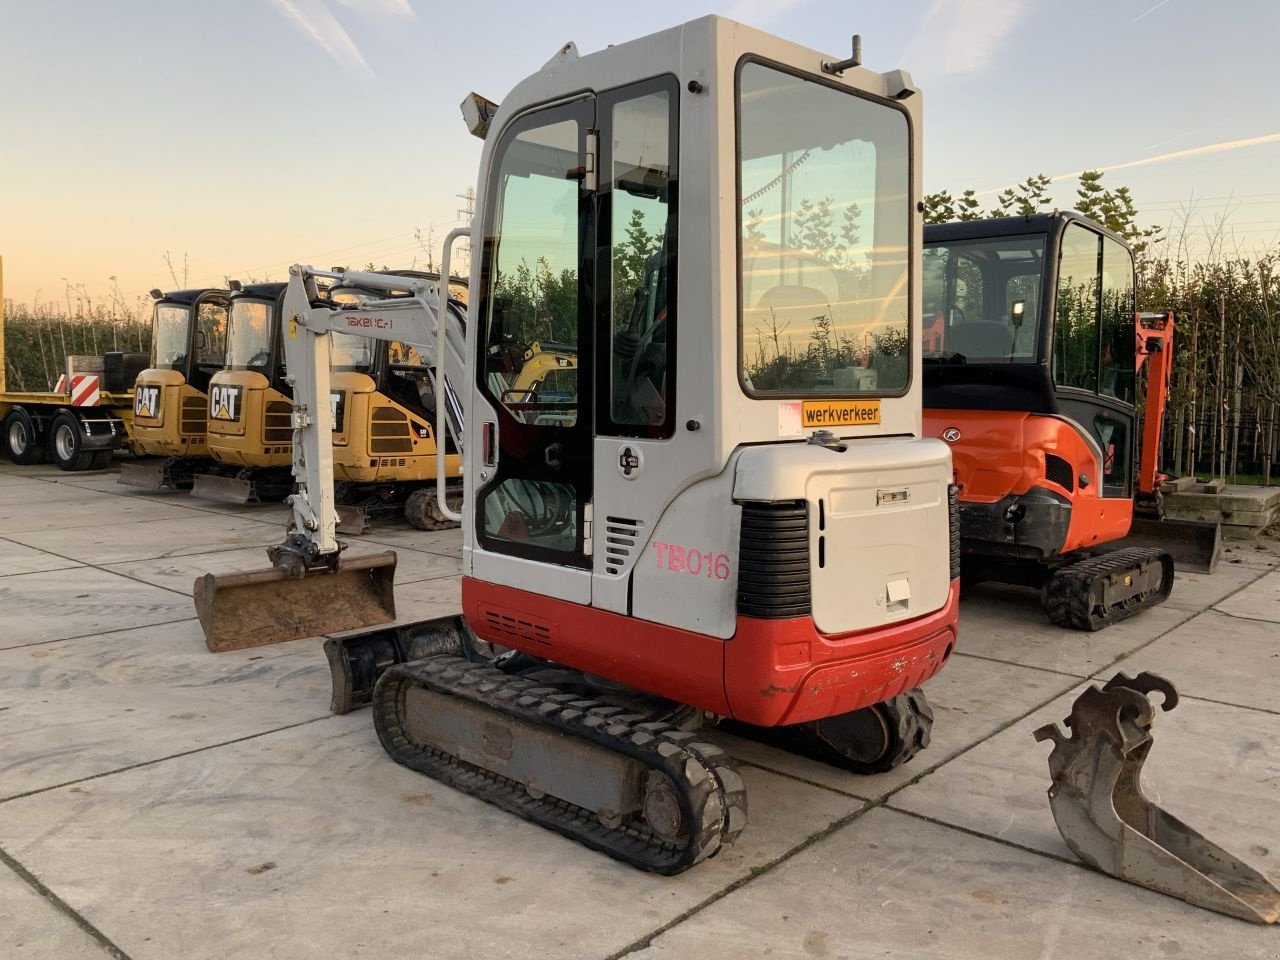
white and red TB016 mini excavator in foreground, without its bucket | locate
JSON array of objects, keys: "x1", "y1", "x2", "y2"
[{"x1": 194, "y1": 17, "x2": 959, "y2": 874}]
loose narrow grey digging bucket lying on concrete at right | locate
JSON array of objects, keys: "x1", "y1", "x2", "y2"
[{"x1": 1034, "y1": 673, "x2": 1280, "y2": 923}]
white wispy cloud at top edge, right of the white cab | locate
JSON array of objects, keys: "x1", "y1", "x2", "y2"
[{"x1": 902, "y1": 0, "x2": 1030, "y2": 77}]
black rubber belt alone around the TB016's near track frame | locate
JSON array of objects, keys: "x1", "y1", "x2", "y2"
[{"x1": 372, "y1": 657, "x2": 746, "y2": 876}]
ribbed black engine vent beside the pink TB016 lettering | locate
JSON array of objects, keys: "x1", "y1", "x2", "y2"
[{"x1": 737, "y1": 500, "x2": 812, "y2": 620}]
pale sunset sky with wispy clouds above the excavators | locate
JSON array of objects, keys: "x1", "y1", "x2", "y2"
[{"x1": 0, "y1": 0, "x2": 1280, "y2": 302}]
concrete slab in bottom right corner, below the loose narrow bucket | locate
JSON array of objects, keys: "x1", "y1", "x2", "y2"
[{"x1": 630, "y1": 809, "x2": 1280, "y2": 960}]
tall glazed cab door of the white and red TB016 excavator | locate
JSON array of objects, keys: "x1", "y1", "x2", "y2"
[{"x1": 468, "y1": 99, "x2": 596, "y2": 603}]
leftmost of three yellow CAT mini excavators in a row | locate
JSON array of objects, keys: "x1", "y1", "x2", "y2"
[{"x1": 120, "y1": 281, "x2": 229, "y2": 489}]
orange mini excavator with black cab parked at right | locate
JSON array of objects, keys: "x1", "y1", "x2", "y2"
[{"x1": 923, "y1": 212, "x2": 1221, "y2": 630}]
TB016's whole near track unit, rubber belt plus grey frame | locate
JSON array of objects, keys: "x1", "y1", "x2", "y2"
[{"x1": 372, "y1": 657, "x2": 746, "y2": 876}]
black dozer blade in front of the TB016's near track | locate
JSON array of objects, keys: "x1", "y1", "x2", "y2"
[{"x1": 324, "y1": 616, "x2": 476, "y2": 713}]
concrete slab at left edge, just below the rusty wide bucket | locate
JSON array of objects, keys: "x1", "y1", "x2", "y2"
[{"x1": 0, "y1": 620, "x2": 330, "y2": 798}]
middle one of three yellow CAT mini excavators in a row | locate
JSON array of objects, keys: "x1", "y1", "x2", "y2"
[{"x1": 192, "y1": 283, "x2": 293, "y2": 503}]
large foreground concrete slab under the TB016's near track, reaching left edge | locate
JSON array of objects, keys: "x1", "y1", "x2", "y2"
[{"x1": 0, "y1": 710, "x2": 861, "y2": 960}]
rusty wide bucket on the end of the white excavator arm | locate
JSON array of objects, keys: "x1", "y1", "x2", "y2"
[{"x1": 192, "y1": 550, "x2": 396, "y2": 653}]
